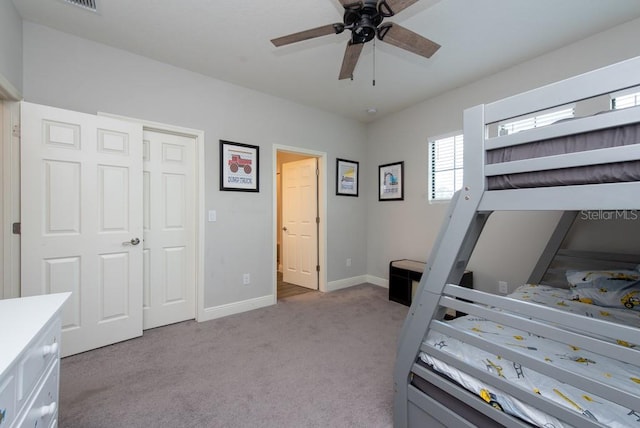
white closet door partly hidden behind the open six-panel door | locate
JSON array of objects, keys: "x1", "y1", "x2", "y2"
[{"x1": 143, "y1": 130, "x2": 196, "y2": 329}]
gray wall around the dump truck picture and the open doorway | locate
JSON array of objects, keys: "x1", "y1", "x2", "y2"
[{"x1": 24, "y1": 22, "x2": 366, "y2": 307}]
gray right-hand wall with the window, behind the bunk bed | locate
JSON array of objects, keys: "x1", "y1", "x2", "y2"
[{"x1": 364, "y1": 20, "x2": 640, "y2": 291}]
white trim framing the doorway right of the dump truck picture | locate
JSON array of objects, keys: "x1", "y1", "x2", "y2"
[{"x1": 271, "y1": 144, "x2": 329, "y2": 296}]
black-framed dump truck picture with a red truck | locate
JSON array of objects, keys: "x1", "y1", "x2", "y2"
[{"x1": 220, "y1": 140, "x2": 260, "y2": 192}]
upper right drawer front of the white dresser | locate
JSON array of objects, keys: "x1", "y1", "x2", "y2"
[{"x1": 17, "y1": 319, "x2": 60, "y2": 407}]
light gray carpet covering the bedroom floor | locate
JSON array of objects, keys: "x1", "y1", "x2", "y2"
[{"x1": 59, "y1": 284, "x2": 408, "y2": 428}]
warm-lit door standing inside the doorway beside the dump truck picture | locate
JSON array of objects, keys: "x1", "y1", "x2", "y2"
[{"x1": 282, "y1": 158, "x2": 318, "y2": 290}]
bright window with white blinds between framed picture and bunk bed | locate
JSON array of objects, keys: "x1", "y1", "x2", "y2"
[{"x1": 429, "y1": 134, "x2": 464, "y2": 201}]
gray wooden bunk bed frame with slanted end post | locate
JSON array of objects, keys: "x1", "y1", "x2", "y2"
[{"x1": 394, "y1": 57, "x2": 640, "y2": 428}]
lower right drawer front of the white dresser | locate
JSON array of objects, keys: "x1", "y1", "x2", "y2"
[{"x1": 16, "y1": 360, "x2": 60, "y2": 428}]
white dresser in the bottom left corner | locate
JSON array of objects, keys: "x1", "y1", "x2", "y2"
[{"x1": 0, "y1": 293, "x2": 71, "y2": 428}]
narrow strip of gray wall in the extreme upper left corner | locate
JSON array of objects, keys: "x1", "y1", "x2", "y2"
[{"x1": 0, "y1": 0, "x2": 22, "y2": 92}]
